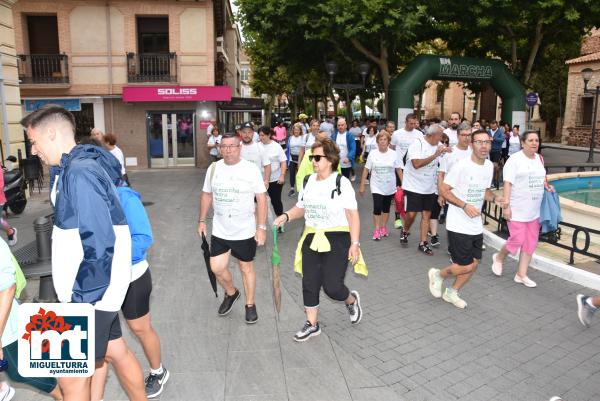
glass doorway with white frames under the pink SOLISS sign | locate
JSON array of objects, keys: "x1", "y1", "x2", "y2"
[{"x1": 146, "y1": 111, "x2": 196, "y2": 168}]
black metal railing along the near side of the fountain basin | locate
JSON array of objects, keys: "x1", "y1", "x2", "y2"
[{"x1": 483, "y1": 202, "x2": 600, "y2": 265}]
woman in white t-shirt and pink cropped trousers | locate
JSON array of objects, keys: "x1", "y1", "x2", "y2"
[{"x1": 492, "y1": 131, "x2": 554, "y2": 287}]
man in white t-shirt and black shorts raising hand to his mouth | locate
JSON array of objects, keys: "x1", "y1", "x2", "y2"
[{"x1": 400, "y1": 124, "x2": 450, "y2": 255}]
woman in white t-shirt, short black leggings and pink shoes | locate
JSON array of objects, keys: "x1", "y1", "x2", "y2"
[{"x1": 358, "y1": 128, "x2": 401, "y2": 241}]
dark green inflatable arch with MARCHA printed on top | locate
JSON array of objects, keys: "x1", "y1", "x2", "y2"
[{"x1": 389, "y1": 55, "x2": 525, "y2": 127}]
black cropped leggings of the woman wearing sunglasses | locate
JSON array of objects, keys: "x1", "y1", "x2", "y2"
[{"x1": 302, "y1": 232, "x2": 350, "y2": 308}]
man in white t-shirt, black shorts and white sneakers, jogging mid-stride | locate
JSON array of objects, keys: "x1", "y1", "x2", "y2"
[{"x1": 428, "y1": 131, "x2": 503, "y2": 309}]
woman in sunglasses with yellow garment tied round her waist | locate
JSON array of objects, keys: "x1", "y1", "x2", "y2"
[{"x1": 273, "y1": 138, "x2": 367, "y2": 341}]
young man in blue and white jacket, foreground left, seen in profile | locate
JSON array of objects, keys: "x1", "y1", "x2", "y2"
[{"x1": 21, "y1": 104, "x2": 146, "y2": 401}]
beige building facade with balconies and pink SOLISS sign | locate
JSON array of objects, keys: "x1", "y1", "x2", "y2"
[{"x1": 12, "y1": 0, "x2": 241, "y2": 168}]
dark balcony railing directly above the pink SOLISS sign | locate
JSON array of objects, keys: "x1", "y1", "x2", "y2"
[{"x1": 127, "y1": 53, "x2": 177, "y2": 83}]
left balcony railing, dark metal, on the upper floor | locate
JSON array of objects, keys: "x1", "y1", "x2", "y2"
[{"x1": 18, "y1": 54, "x2": 69, "y2": 84}]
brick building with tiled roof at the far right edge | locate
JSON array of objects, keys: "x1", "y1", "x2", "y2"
[{"x1": 562, "y1": 29, "x2": 600, "y2": 146}]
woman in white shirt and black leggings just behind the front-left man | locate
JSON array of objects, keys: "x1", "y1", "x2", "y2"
[{"x1": 258, "y1": 127, "x2": 287, "y2": 222}]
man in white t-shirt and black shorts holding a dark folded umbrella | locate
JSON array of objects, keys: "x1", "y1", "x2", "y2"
[{"x1": 198, "y1": 134, "x2": 267, "y2": 324}]
